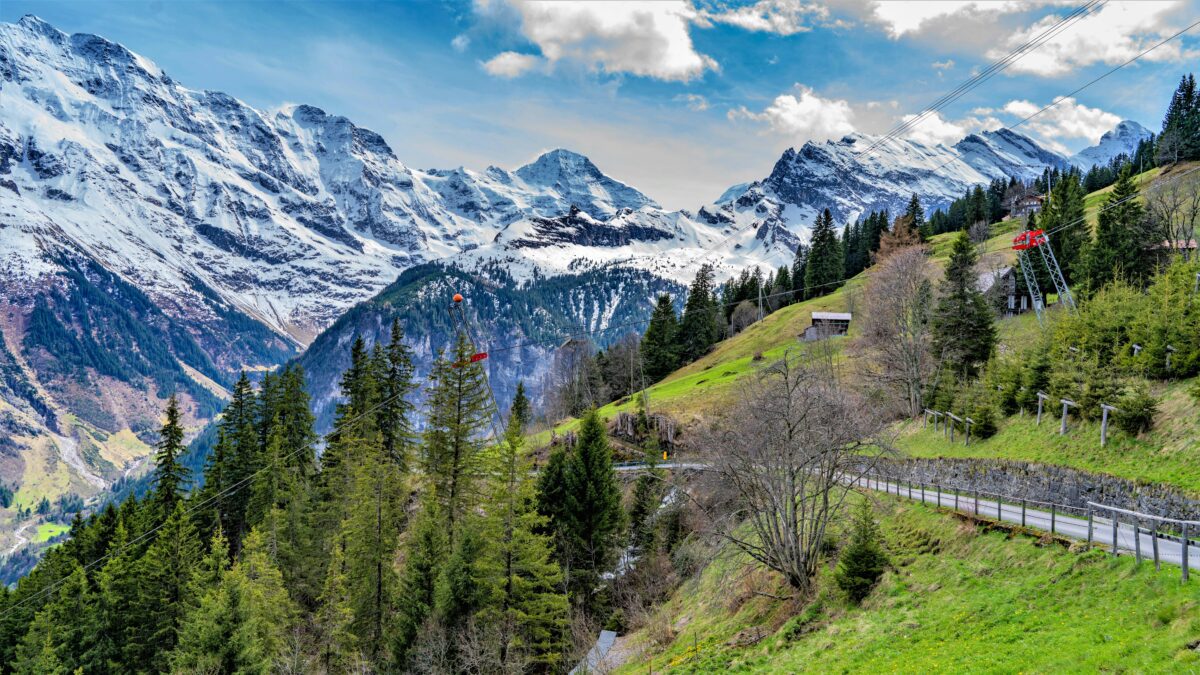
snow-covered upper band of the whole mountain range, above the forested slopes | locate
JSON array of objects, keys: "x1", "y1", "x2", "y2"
[{"x1": 0, "y1": 17, "x2": 1094, "y2": 342}]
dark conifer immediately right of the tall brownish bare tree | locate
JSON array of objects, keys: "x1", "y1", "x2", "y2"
[{"x1": 934, "y1": 232, "x2": 996, "y2": 377}]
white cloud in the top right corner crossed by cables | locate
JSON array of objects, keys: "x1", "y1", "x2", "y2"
[{"x1": 988, "y1": 1, "x2": 1200, "y2": 77}]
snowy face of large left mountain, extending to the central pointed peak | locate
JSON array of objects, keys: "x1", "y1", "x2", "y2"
[{"x1": 0, "y1": 17, "x2": 686, "y2": 341}]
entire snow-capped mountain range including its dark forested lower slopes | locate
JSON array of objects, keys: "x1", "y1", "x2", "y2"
[{"x1": 0, "y1": 17, "x2": 1084, "y2": 552}]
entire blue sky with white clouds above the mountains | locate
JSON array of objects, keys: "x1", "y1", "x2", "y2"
[{"x1": 0, "y1": 0, "x2": 1200, "y2": 208}]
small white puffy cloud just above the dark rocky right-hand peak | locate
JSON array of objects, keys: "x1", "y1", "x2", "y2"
[{"x1": 728, "y1": 84, "x2": 854, "y2": 143}]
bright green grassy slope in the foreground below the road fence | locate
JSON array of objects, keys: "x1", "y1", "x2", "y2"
[{"x1": 619, "y1": 497, "x2": 1200, "y2": 673}]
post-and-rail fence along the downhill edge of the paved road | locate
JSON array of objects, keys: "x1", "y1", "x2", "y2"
[{"x1": 853, "y1": 472, "x2": 1200, "y2": 581}]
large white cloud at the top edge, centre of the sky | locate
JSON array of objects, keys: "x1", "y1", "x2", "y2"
[{"x1": 478, "y1": 0, "x2": 718, "y2": 82}]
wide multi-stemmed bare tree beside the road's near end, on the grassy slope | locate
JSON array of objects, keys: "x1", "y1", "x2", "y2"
[{"x1": 704, "y1": 350, "x2": 886, "y2": 596}]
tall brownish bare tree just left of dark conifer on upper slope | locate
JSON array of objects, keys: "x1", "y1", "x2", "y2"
[{"x1": 854, "y1": 246, "x2": 937, "y2": 417}]
